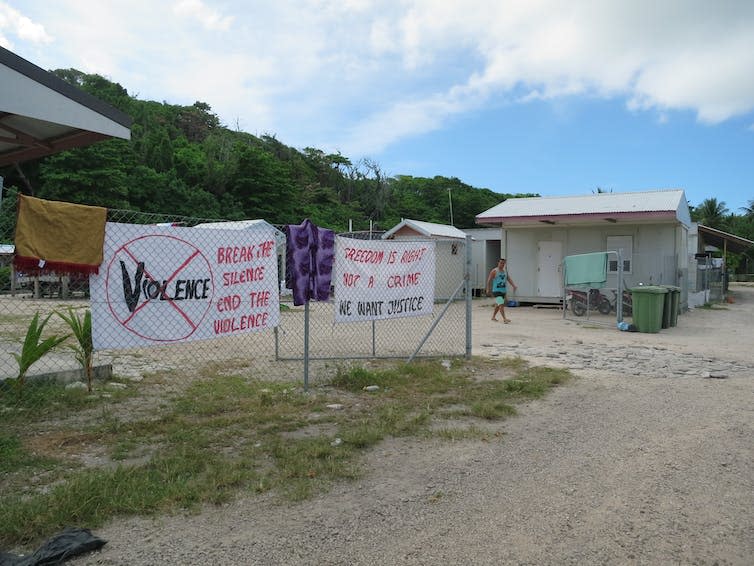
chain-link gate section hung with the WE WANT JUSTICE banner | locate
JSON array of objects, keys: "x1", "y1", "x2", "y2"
[{"x1": 276, "y1": 234, "x2": 467, "y2": 359}]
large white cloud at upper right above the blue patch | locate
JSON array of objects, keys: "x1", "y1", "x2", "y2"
[{"x1": 330, "y1": 0, "x2": 754, "y2": 153}]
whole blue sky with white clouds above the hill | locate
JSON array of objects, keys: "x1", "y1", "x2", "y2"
[{"x1": 0, "y1": 0, "x2": 754, "y2": 213}]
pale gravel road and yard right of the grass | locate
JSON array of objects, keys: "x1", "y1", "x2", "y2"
[{"x1": 74, "y1": 286, "x2": 754, "y2": 565}]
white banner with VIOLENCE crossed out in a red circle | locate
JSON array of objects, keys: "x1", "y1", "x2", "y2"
[{"x1": 89, "y1": 222, "x2": 280, "y2": 349}]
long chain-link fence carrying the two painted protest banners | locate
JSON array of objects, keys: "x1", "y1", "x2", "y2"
[{"x1": 0, "y1": 195, "x2": 470, "y2": 406}]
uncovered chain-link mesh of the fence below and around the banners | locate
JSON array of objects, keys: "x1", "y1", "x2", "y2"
[{"x1": 0, "y1": 197, "x2": 466, "y2": 400}]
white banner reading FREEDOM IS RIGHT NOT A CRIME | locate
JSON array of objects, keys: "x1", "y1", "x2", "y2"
[{"x1": 333, "y1": 237, "x2": 435, "y2": 322}]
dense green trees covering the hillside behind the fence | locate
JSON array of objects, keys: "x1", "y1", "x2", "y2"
[{"x1": 0, "y1": 69, "x2": 532, "y2": 231}]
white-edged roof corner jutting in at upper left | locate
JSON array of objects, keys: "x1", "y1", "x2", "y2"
[{"x1": 0, "y1": 47, "x2": 131, "y2": 167}]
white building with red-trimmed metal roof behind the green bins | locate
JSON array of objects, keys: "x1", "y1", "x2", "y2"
[{"x1": 476, "y1": 189, "x2": 691, "y2": 305}]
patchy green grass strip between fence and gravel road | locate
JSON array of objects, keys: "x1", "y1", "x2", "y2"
[{"x1": 0, "y1": 359, "x2": 570, "y2": 547}]
